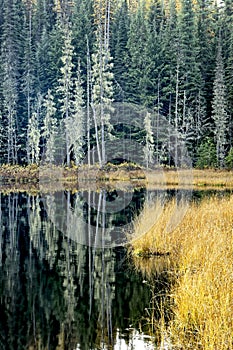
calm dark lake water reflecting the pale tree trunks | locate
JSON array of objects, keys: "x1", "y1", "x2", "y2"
[{"x1": 0, "y1": 188, "x2": 232, "y2": 350}]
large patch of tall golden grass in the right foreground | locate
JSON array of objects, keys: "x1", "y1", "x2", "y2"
[{"x1": 132, "y1": 195, "x2": 233, "y2": 350}]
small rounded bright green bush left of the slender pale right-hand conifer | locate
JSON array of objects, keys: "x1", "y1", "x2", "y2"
[{"x1": 196, "y1": 137, "x2": 217, "y2": 169}]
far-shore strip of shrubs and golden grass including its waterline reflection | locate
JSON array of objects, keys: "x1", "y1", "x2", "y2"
[{"x1": 0, "y1": 163, "x2": 233, "y2": 189}]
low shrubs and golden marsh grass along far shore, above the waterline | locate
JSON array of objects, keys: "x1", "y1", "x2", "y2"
[{"x1": 0, "y1": 163, "x2": 233, "y2": 188}]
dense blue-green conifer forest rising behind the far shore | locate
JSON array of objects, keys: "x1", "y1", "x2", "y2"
[{"x1": 0, "y1": 0, "x2": 233, "y2": 167}]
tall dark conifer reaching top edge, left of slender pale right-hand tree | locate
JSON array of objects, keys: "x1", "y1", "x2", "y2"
[{"x1": 177, "y1": 0, "x2": 206, "y2": 157}]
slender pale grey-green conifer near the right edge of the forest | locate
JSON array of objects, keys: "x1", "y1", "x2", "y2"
[{"x1": 212, "y1": 35, "x2": 228, "y2": 167}]
